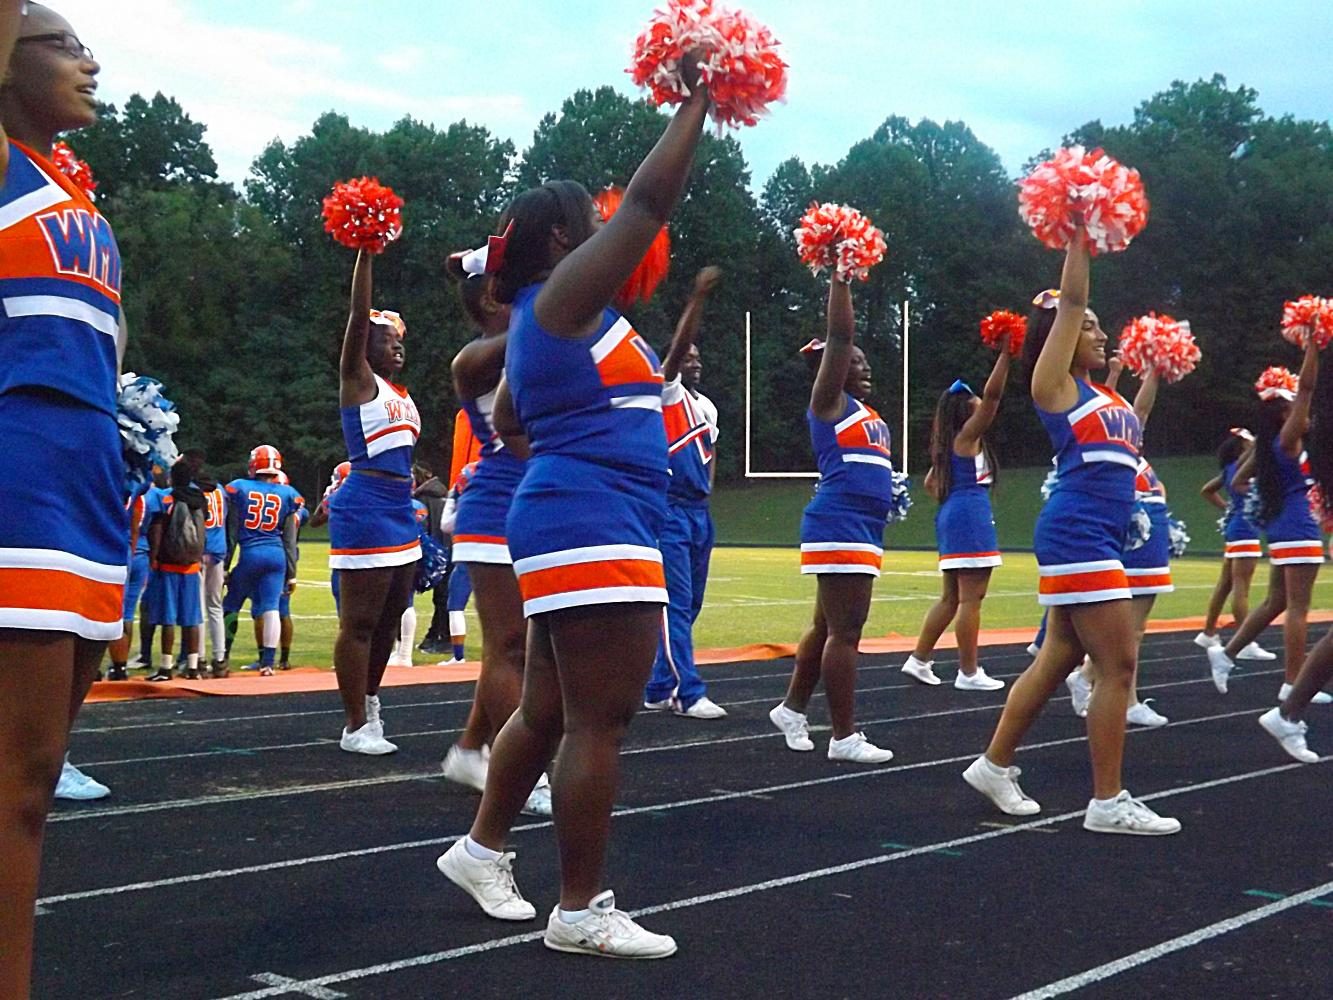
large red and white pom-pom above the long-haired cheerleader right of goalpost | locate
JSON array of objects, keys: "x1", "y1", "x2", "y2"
[{"x1": 1018, "y1": 145, "x2": 1148, "y2": 255}]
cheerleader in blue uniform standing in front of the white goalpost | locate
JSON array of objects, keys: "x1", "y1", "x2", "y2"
[{"x1": 768, "y1": 276, "x2": 893, "y2": 764}]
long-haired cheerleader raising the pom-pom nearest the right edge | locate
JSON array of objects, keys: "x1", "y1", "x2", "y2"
[{"x1": 1206, "y1": 337, "x2": 1333, "y2": 704}]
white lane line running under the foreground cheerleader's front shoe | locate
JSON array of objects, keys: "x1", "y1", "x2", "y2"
[{"x1": 207, "y1": 757, "x2": 1333, "y2": 1000}]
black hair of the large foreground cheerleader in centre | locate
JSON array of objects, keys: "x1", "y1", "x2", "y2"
[{"x1": 495, "y1": 180, "x2": 593, "y2": 304}]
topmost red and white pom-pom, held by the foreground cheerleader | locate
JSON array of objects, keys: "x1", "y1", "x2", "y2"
[{"x1": 625, "y1": 0, "x2": 786, "y2": 128}]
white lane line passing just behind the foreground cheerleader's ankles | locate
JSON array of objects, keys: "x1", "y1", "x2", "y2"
[{"x1": 37, "y1": 708, "x2": 1279, "y2": 907}]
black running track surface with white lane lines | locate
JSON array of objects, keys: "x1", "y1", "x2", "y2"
[{"x1": 35, "y1": 635, "x2": 1333, "y2": 1000}]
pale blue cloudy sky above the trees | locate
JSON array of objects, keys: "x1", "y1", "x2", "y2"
[{"x1": 49, "y1": 0, "x2": 1333, "y2": 192}]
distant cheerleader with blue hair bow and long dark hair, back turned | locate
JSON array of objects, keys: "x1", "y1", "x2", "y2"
[{"x1": 902, "y1": 336, "x2": 1009, "y2": 691}]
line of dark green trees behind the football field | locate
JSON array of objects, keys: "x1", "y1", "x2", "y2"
[{"x1": 71, "y1": 76, "x2": 1333, "y2": 491}]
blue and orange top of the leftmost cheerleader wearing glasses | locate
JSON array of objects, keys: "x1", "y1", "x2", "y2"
[{"x1": 0, "y1": 140, "x2": 121, "y2": 415}]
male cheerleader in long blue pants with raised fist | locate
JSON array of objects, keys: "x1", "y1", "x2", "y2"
[{"x1": 644, "y1": 267, "x2": 726, "y2": 719}]
